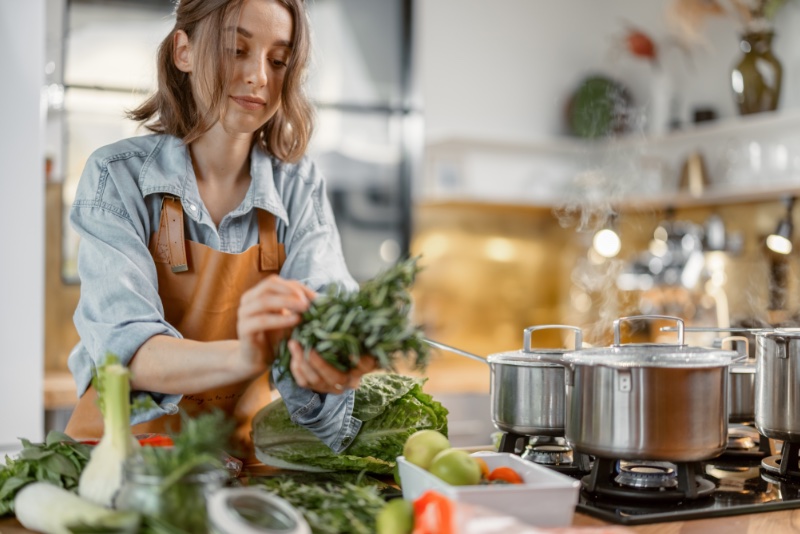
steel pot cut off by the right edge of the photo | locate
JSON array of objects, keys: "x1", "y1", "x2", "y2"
[{"x1": 755, "y1": 328, "x2": 800, "y2": 442}]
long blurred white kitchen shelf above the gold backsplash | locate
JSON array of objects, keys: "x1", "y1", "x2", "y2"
[{"x1": 419, "y1": 109, "x2": 800, "y2": 210}]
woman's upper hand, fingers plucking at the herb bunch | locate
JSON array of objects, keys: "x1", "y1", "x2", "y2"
[{"x1": 236, "y1": 275, "x2": 317, "y2": 376}]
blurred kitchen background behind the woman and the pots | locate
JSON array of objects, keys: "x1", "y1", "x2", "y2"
[{"x1": 0, "y1": 0, "x2": 800, "y2": 449}]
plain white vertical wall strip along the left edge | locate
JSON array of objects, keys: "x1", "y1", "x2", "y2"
[{"x1": 0, "y1": 0, "x2": 45, "y2": 450}]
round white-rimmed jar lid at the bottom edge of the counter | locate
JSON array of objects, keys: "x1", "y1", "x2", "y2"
[{"x1": 207, "y1": 487, "x2": 311, "y2": 534}]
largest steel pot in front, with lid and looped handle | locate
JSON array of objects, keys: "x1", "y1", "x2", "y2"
[{"x1": 564, "y1": 315, "x2": 736, "y2": 462}]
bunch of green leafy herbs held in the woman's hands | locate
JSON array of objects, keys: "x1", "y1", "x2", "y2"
[{"x1": 276, "y1": 258, "x2": 428, "y2": 372}]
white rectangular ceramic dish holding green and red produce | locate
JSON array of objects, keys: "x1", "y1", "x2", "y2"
[{"x1": 397, "y1": 452, "x2": 580, "y2": 527}]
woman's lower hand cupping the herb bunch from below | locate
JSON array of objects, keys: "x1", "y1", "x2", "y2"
[{"x1": 289, "y1": 339, "x2": 377, "y2": 394}]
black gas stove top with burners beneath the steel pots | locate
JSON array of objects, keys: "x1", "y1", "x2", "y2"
[{"x1": 506, "y1": 430, "x2": 800, "y2": 525}]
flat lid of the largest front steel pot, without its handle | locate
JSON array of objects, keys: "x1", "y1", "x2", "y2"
[{"x1": 564, "y1": 344, "x2": 739, "y2": 369}]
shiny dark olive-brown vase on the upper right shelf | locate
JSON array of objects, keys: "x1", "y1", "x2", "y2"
[{"x1": 731, "y1": 31, "x2": 783, "y2": 115}]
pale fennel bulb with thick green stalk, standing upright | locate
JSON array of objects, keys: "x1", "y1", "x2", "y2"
[{"x1": 78, "y1": 356, "x2": 140, "y2": 507}]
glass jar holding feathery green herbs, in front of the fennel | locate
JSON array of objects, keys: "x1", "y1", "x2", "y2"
[{"x1": 114, "y1": 462, "x2": 229, "y2": 533}]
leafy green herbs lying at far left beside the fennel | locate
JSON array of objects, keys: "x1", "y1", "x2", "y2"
[{"x1": 0, "y1": 430, "x2": 91, "y2": 516}]
